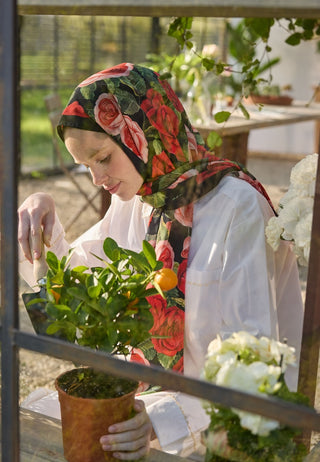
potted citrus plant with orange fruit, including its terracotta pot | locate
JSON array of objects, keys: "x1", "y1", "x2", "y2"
[{"x1": 27, "y1": 238, "x2": 176, "y2": 462}]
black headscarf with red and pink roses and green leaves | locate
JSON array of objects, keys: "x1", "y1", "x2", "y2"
[{"x1": 58, "y1": 63, "x2": 271, "y2": 372}]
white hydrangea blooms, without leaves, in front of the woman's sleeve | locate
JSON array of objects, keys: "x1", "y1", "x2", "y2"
[{"x1": 202, "y1": 331, "x2": 296, "y2": 436}]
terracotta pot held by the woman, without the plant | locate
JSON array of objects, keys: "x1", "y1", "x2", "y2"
[{"x1": 55, "y1": 368, "x2": 136, "y2": 462}]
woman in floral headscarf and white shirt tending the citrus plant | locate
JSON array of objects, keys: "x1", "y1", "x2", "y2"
[{"x1": 19, "y1": 63, "x2": 303, "y2": 459}]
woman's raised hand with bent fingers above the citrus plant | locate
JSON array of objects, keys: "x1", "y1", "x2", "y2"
[{"x1": 18, "y1": 193, "x2": 55, "y2": 263}]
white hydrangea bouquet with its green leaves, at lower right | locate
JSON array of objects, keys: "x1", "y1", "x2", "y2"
[{"x1": 203, "y1": 332, "x2": 308, "y2": 462}]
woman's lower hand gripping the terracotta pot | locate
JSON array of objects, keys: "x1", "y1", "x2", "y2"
[{"x1": 100, "y1": 400, "x2": 153, "y2": 460}]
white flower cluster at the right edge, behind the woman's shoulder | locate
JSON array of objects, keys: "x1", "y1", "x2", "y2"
[{"x1": 266, "y1": 154, "x2": 318, "y2": 266}]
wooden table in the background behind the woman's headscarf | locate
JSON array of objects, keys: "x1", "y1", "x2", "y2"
[{"x1": 195, "y1": 101, "x2": 320, "y2": 165}]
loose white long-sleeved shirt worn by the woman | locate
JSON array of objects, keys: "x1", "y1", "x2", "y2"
[{"x1": 20, "y1": 176, "x2": 303, "y2": 456}]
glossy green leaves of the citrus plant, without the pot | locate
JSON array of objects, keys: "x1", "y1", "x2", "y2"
[{"x1": 30, "y1": 238, "x2": 163, "y2": 355}]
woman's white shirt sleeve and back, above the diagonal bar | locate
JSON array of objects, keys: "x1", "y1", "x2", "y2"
[{"x1": 185, "y1": 177, "x2": 303, "y2": 387}]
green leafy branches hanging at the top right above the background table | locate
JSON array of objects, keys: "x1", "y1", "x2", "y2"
[{"x1": 168, "y1": 18, "x2": 320, "y2": 132}]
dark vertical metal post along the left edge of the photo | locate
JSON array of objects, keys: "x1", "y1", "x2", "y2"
[{"x1": 0, "y1": 0, "x2": 20, "y2": 462}]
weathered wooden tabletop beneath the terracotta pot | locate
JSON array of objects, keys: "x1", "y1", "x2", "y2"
[{"x1": 20, "y1": 409, "x2": 201, "y2": 462}]
